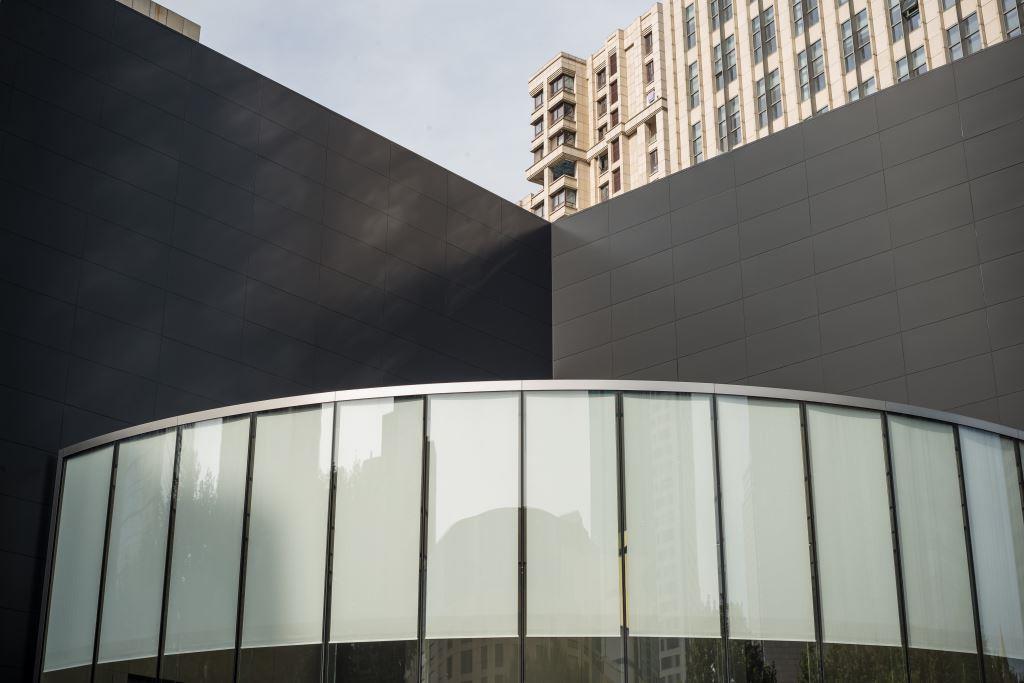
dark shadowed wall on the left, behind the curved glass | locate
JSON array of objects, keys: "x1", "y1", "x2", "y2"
[{"x1": 0, "y1": 0, "x2": 551, "y2": 681}]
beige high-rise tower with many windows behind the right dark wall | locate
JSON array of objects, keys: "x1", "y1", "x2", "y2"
[{"x1": 520, "y1": 0, "x2": 1024, "y2": 220}]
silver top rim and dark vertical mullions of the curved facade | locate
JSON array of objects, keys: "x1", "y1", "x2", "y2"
[{"x1": 36, "y1": 380, "x2": 1024, "y2": 681}]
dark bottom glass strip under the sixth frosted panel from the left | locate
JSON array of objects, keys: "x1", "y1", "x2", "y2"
[{"x1": 423, "y1": 638, "x2": 520, "y2": 683}]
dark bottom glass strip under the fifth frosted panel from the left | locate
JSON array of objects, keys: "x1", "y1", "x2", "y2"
[{"x1": 327, "y1": 640, "x2": 419, "y2": 683}]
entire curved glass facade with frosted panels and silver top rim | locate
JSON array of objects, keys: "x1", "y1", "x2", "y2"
[{"x1": 42, "y1": 382, "x2": 1024, "y2": 683}]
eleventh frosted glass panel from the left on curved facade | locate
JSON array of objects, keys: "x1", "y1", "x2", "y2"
[{"x1": 889, "y1": 416, "x2": 977, "y2": 652}]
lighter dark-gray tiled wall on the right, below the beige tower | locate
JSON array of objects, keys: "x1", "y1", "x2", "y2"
[{"x1": 552, "y1": 40, "x2": 1024, "y2": 427}]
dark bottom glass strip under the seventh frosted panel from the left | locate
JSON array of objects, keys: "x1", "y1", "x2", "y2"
[{"x1": 526, "y1": 637, "x2": 625, "y2": 683}]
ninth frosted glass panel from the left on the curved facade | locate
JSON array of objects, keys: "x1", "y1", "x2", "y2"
[{"x1": 718, "y1": 396, "x2": 814, "y2": 640}]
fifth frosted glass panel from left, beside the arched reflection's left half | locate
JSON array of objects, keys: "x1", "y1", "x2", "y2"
[{"x1": 331, "y1": 398, "x2": 423, "y2": 642}]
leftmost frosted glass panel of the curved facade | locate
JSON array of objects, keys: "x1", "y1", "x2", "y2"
[{"x1": 43, "y1": 446, "x2": 114, "y2": 671}]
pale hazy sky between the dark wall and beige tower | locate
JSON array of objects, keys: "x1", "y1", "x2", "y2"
[{"x1": 160, "y1": 0, "x2": 654, "y2": 202}]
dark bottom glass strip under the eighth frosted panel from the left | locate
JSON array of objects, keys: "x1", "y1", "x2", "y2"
[{"x1": 629, "y1": 637, "x2": 722, "y2": 683}]
